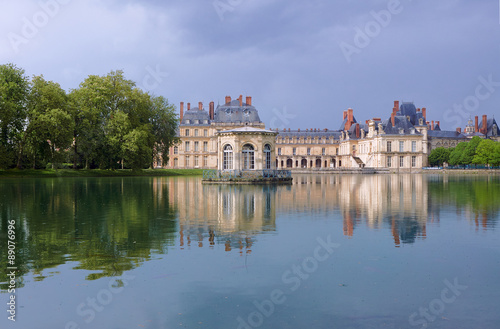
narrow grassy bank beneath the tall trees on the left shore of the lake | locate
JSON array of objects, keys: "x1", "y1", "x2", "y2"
[{"x1": 0, "y1": 169, "x2": 203, "y2": 179}]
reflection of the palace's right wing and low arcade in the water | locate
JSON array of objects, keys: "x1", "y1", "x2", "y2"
[{"x1": 277, "y1": 174, "x2": 428, "y2": 247}]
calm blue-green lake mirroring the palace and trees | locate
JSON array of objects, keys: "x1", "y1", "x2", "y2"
[{"x1": 0, "y1": 175, "x2": 500, "y2": 329}]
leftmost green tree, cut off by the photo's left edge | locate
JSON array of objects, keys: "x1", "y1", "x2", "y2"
[{"x1": 0, "y1": 64, "x2": 29, "y2": 168}]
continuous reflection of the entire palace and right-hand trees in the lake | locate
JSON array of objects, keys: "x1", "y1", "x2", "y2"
[{"x1": 163, "y1": 174, "x2": 500, "y2": 249}]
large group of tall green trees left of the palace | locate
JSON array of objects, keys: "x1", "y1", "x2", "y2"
[{"x1": 0, "y1": 63, "x2": 178, "y2": 169}]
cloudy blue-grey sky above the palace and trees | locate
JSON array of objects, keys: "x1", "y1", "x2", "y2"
[{"x1": 0, "y1": 0, "x2": 500, "y2": 130}]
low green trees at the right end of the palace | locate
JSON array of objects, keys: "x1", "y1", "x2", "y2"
[{"x1": 429, "y1": 136, "x2": 500, "y2": 167}]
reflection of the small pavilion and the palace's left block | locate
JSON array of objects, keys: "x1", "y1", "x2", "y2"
[{"x1": 169, "y1": 178, "x2": 279, "y2": 254}]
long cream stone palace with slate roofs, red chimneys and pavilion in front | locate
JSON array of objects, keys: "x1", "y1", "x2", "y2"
[{"x1": 164, "y1": 95, "x2": 500, "y2": 171}]
